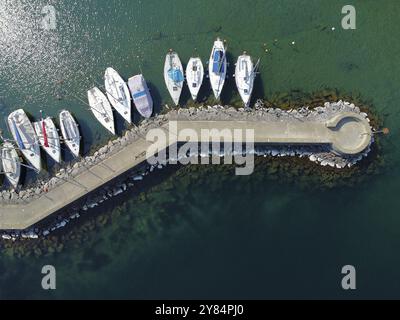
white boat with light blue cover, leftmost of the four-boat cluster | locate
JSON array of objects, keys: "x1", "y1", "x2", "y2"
[{"x1": 164, "y1": 50, "x2": 185, "y2": 105}]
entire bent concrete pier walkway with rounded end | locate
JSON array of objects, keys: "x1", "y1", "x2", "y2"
[{"x1": 0, "y1": 112, "x2": 372, "y2": 230}]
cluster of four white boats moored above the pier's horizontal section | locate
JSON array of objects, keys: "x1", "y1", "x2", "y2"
[{"x1": 164, "y1": 38, "x2": 260, "y2": 107}]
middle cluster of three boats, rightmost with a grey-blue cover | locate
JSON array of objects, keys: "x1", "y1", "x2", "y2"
[{"x1": 88, "y1": 68, "x2": 153, "y2": 135}]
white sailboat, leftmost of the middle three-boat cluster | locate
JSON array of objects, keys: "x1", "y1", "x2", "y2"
[{"x1": 88, "y1": 87, "x2": 115, "y2": 134}]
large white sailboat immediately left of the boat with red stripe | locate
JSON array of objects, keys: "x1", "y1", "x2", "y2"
[{"x1": 8, "y1": 109, "x2": 42, "y2": 172}]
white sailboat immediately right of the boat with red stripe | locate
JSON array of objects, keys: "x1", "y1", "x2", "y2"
[{"x1": 60, "y1": 110, "x2": 81, "y2": 157}]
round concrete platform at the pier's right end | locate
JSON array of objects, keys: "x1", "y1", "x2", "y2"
[{"x1": 326, "y1": 112, "x2": 372, "y2": 155}]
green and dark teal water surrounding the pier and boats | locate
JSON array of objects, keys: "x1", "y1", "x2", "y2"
[{"x1": 0, "y1": 0, "x2": 400, "y2": 298}]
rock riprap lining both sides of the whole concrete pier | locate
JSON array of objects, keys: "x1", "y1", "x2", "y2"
[{"x1": 0, "y1": 101, "x2": 373, "y2": 241}]
